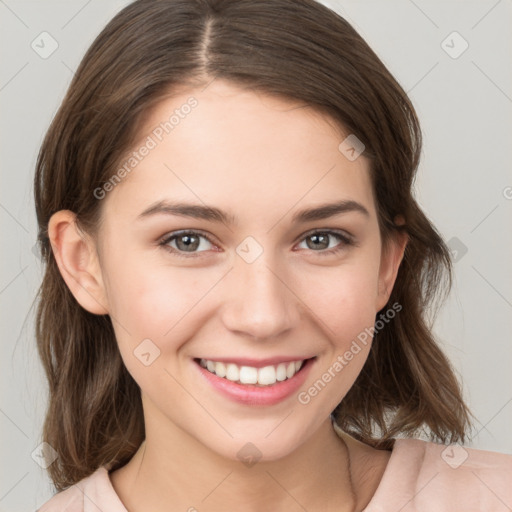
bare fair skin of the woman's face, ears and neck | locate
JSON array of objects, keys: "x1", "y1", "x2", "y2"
[{"x1": 49, "y1": 80, "x2": 406, "y2": 512}]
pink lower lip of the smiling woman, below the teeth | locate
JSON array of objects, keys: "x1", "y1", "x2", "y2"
[{"x1": 194, "y1": 358, "x2": 315, "y2": 405}]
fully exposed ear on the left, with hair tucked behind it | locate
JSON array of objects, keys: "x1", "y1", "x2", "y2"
[{"x1": 48, "y1": 210, "x2": 108, "y2": 315}]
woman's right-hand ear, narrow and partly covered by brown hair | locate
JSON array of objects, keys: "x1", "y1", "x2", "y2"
[{"x1": 375, "y1": 216, "x2": 408, "y2": 311}]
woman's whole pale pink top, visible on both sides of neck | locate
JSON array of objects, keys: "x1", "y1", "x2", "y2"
[{"x1": 36, "y1": 439, "x2": 512, "y2": 512}]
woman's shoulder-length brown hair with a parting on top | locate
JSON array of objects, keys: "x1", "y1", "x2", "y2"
[{"x1": 34, "y1": 0, "x2": 470, "y2": 491}]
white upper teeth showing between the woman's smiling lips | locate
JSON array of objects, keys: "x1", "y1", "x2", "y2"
[{"x1": 194, "y1": 358, "x2": 314, "y2": 387}]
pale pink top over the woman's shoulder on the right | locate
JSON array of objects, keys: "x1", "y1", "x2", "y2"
[{"x1": 365, "y1": 439, "x2": 512, "y2": 512}]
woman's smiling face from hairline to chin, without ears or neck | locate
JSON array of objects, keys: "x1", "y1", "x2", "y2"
[{"x1": 58, "y1": 80, "x2": 406, "y2": 460}]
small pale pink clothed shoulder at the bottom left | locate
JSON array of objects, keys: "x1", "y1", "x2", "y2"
[{"x1": 36, "y1": 466, "x2": 127, "y2": 512}]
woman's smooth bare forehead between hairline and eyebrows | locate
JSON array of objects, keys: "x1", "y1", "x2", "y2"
[{"x1": 107, "y1": 80, "x2": 373, "y2": 222}]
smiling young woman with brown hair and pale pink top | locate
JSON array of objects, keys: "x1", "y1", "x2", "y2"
[{"x1": 35, "y1": 0, "x2": 512, "y2": 512}]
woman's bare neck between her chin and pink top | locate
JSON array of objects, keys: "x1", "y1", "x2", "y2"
[{"x1": 110, "y1": 412, "x2": 356, "y2": 512}]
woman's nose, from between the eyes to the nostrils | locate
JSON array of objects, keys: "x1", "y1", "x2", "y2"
[{"x1": 222, "y1": 251, "x2": 301, "y2": 340}]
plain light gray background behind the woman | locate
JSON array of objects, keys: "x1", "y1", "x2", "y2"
[{"x1": 0, "y1": 0, "x2": 512, "y2": 512}]
